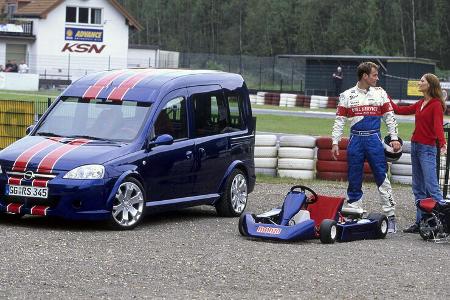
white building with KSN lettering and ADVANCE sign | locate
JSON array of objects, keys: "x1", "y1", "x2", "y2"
[{"x1": 0, "y1": 0, "x2": 178, "y2": 85}]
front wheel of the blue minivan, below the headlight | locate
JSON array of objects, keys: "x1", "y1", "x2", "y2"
[{"x1": 109, "y1": 177, "x2": 145, "y2": 230}]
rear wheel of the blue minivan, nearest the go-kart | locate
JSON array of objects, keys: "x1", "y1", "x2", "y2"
[{"x1": 216, "y1": 169, "x2": 248, "y2": 217}]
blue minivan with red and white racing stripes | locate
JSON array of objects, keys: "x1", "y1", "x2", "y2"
[{"x1": 0, "y1": 69, "x2": 255, "y2": 229}]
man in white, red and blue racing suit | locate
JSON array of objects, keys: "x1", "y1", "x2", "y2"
[{"x1": 331, "y1": 62, "x2": 401, "y2": 233}]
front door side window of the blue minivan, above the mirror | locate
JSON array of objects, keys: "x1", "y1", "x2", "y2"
[{"x1": 155, "y1": 97, "x2": 188, "y2": 140}]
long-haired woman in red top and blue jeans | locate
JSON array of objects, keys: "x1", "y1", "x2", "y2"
[{"x1": 391, "y1": 73, "x2": 447, "y2": 233}]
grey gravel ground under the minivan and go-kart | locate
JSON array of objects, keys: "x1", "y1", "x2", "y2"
[{"x1": 0, "y1": 181, "x2": 450, "y2": 299}]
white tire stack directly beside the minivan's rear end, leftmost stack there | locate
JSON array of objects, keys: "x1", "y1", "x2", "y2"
[{"x1": 255, "y1": 134, "x2": 278, "y2": 176}]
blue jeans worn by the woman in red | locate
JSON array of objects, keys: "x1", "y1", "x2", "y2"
[{"x1": 411, "y1": 142, "x2": 444, "y2": 223}]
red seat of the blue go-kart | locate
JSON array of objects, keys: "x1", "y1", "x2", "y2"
[{"x1": 306, "y1": 195, "x2": 345, "y2": 226}]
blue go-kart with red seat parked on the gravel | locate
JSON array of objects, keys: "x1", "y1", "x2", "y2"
[{"x1": 239, "y1": 185, "x2": 388, "y2": 244}]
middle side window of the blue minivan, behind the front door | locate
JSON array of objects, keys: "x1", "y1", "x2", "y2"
[{"x1": 192, "y1": 92, "x2": 229, "y2": 137}]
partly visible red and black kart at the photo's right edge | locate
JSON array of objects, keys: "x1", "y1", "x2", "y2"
[{"x1": 417, "y1": 198, "x2": 450, "y2": 243}]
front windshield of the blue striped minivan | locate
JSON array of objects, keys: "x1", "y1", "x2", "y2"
[{"x1": 34, "y1": 97, "x2": 151, "y2": 142}]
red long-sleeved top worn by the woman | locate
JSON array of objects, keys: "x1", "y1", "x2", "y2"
[{"x1": 391, "y1": 98, "x2": 446, "y2": 147}]
